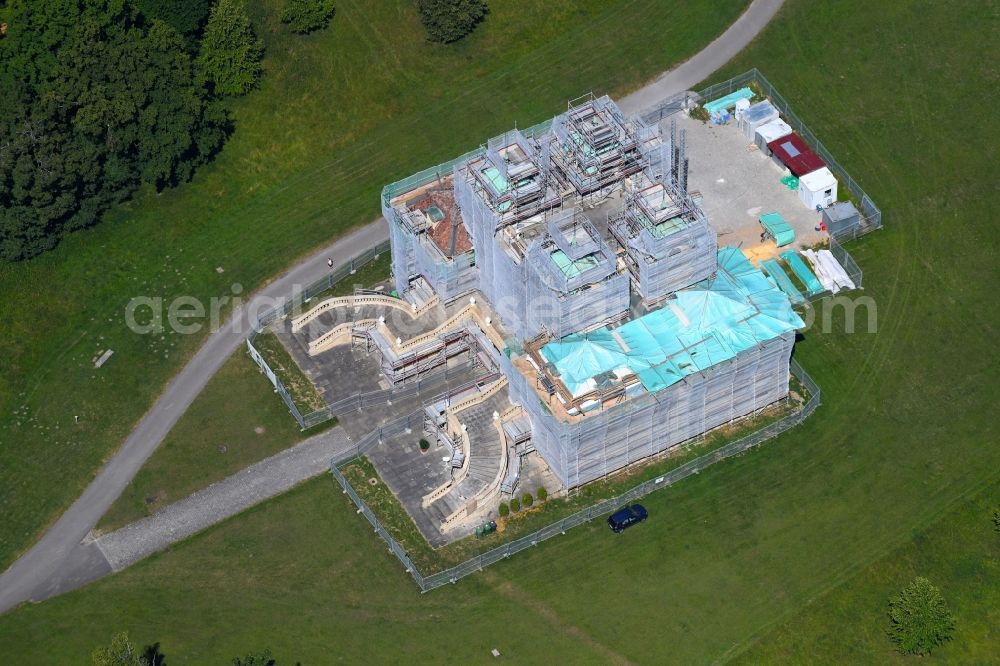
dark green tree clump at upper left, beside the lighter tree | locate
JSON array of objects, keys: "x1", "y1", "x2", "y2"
[{"x1": 0, "y1": 0, "x2": 228, "y2": 260}]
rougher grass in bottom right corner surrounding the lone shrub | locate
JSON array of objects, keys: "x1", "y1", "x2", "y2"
[{"x1": 735, "y1": 474, "x2": 1000, "y2": 664}]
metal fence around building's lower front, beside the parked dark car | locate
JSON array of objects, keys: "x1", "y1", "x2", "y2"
[{"x1": 330, "y1": 359, "x2": 820, "y2": 592}]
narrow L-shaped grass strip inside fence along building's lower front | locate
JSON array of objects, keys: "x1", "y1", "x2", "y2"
[{"x1": 341, "y1": 388, "x2": 806, "y2": 575}]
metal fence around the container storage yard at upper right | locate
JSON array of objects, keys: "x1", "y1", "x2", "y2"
[{"x1": 641, "y1": 67, "x2": 882, "y2": 241}]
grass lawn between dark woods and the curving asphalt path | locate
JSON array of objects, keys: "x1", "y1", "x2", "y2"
[{"x1": 0, "y1": 0, "x2": 748, "y2": 566}]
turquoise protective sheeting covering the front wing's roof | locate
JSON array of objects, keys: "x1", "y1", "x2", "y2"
[{"x1": 541, "y1": 247, "x2": 805, "y2": 397}]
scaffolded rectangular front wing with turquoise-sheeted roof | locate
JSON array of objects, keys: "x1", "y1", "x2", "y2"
[{"x1": 501, "y1": 248, "x2": 804, "y2": 488}]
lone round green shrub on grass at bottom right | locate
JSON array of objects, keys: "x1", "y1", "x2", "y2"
[{"x1": 889, "y1": 577, "x2": 955, "y2": 655}]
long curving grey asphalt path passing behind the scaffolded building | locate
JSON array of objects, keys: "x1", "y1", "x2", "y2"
[{"x1": 0, "y1": 0, "x2": 783, "y2": 613}]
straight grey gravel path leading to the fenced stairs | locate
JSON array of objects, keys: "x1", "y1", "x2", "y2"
[{"x1": 95, "y1": 426, "x2": 354, "y2": 571}]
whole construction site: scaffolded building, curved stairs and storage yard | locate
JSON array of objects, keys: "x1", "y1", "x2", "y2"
[{"x1": 268, "y1": 89, "x2": 859, "y2": 547}]
